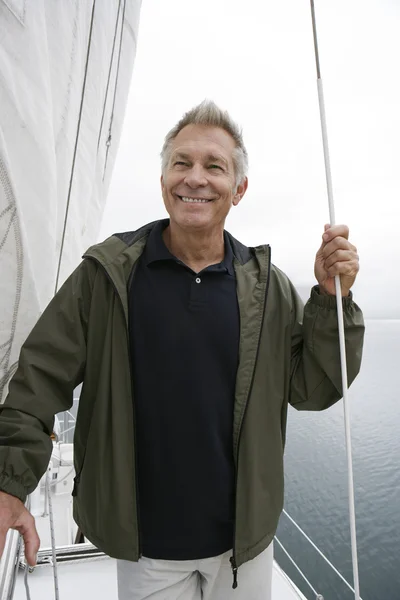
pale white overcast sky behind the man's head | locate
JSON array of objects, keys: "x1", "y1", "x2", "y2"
[{"x1": 99, "y1": 0, "x2": 400, "y2": 318}]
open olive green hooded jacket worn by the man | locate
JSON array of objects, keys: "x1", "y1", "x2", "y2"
[{"x1": 0, "y1": 223, "x2": 364, "y2": 566}]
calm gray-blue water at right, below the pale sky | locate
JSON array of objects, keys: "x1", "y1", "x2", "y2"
[{"x1": 275, "y1": 321, "x2": 400, "y2": 600}]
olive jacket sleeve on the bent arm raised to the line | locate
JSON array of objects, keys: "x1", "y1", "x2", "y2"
[{"x1": 289, "y1": 286, "x2": 364, "y2": 410}]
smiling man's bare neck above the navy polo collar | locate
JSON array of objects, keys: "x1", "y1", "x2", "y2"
[{"x1": 163, "y1": 223, "x2": 225, "y2": 273}]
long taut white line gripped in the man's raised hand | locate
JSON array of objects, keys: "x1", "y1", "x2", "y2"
[{"x1": 311, "y1": 0, "x2": 360, "y2": 600}]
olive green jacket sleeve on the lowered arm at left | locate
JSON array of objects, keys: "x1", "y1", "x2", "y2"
[{"x1": 0, "y1": 260, "x2": 96, "y2": 502}]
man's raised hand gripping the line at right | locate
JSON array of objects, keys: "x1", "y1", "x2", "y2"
[{"x1": 314, "y1": 225, "x2": 360, "y2": 296}]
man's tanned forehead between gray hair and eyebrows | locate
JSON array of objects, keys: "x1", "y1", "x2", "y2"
[{"x1": 171, "y1": 125, "x2": 236, "y2": 160}]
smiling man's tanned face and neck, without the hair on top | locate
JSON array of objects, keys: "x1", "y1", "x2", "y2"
[{"x1": 161, "y1": 122, "x2": 247, "y2": 271}]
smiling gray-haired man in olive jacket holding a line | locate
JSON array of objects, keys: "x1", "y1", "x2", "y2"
[{"x1": 0, "y1": 102, "x2": 364, "y2": 600}]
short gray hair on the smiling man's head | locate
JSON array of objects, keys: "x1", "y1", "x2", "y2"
[{"x1": 161, "y1": 100, "x2": 249, "y2": 187}]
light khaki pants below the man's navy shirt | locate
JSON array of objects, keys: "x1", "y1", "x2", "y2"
[{"x1": 117, "y1": 544, "x2": 273, "y2": 600}]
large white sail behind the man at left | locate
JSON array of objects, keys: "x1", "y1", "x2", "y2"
[{"x1": 0, "y1": 0, "x2": 141, "y2": 400}]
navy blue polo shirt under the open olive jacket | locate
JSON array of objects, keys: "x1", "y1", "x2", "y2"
[{"x1": 129, "y1": 221, "x2": 240, "y2": 560}]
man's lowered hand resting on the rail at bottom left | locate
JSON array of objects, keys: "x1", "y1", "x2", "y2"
[{"x1": 0, "y1": 492, "x2": 40, "y2": 567}]
